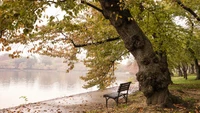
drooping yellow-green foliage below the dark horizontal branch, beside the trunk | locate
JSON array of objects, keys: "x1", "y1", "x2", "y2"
[{"x1": 81, "y1": 41, "x2": 127, "y2": 89}]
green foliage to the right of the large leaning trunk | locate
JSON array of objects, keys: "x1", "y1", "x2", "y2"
[{"x1": 126, "y1": 0, "x2": 199, "y2": 68}]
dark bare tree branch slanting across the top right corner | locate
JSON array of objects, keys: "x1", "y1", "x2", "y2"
[{"x1": 175, "y1": 0, "x2": 200, "y2": 21}]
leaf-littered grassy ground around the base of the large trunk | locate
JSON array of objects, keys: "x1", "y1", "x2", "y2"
[{"x1": 88, "y1": 75, "x2": 200, "y2": 113}]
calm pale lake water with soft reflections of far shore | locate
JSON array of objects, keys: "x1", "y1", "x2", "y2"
[{"x1": 0, "y1": 70, "x2": 134, "y2": 109}]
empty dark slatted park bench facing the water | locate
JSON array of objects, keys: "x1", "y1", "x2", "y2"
[{"x1": 103, "y1": 82, "x2": 131, "y2": 107}]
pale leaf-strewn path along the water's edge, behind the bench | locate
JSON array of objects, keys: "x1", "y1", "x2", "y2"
[{"x1": 0, "y1": 83, "x2": 137, "y2": 113}]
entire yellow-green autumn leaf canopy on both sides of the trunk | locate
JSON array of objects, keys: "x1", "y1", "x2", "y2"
[{"x1": 0, "y1": 0, "x2": 200, "y2": 88}]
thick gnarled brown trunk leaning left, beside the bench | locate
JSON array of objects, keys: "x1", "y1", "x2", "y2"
[{"x1": 99, "y1": 0, "x2": 172, "y2": 107}]
